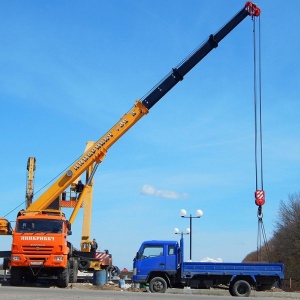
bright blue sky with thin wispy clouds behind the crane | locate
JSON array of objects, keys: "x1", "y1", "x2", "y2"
[{"x1": 0, "y1": 0, "x2": 300, "y2": 269}]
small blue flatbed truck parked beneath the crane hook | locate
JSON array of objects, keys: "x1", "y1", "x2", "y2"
[{"x1": 132, "y1": 238, "x2": 284, "y2": 297}]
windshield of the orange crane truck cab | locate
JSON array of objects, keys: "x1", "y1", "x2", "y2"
[{"x1": 16, "y1": 219, "x2": 62, "y2": 233}]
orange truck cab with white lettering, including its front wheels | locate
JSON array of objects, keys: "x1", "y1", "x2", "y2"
[{"x1": 10, "y1": 212, "x2": 78, "y2": 287}]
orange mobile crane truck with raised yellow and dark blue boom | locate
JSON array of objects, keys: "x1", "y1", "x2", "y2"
[{"x1": 0, "y1": 2, "x2": 270, "y2": 287}]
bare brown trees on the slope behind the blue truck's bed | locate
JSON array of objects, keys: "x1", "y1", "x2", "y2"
[{"x1": 243, "y1": 193, "x2": 300, "y2": 280}]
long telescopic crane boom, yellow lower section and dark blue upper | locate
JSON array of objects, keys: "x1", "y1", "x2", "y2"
[{"x1": 26, "y1": 2, "x2": 260, "y2": 212}]
